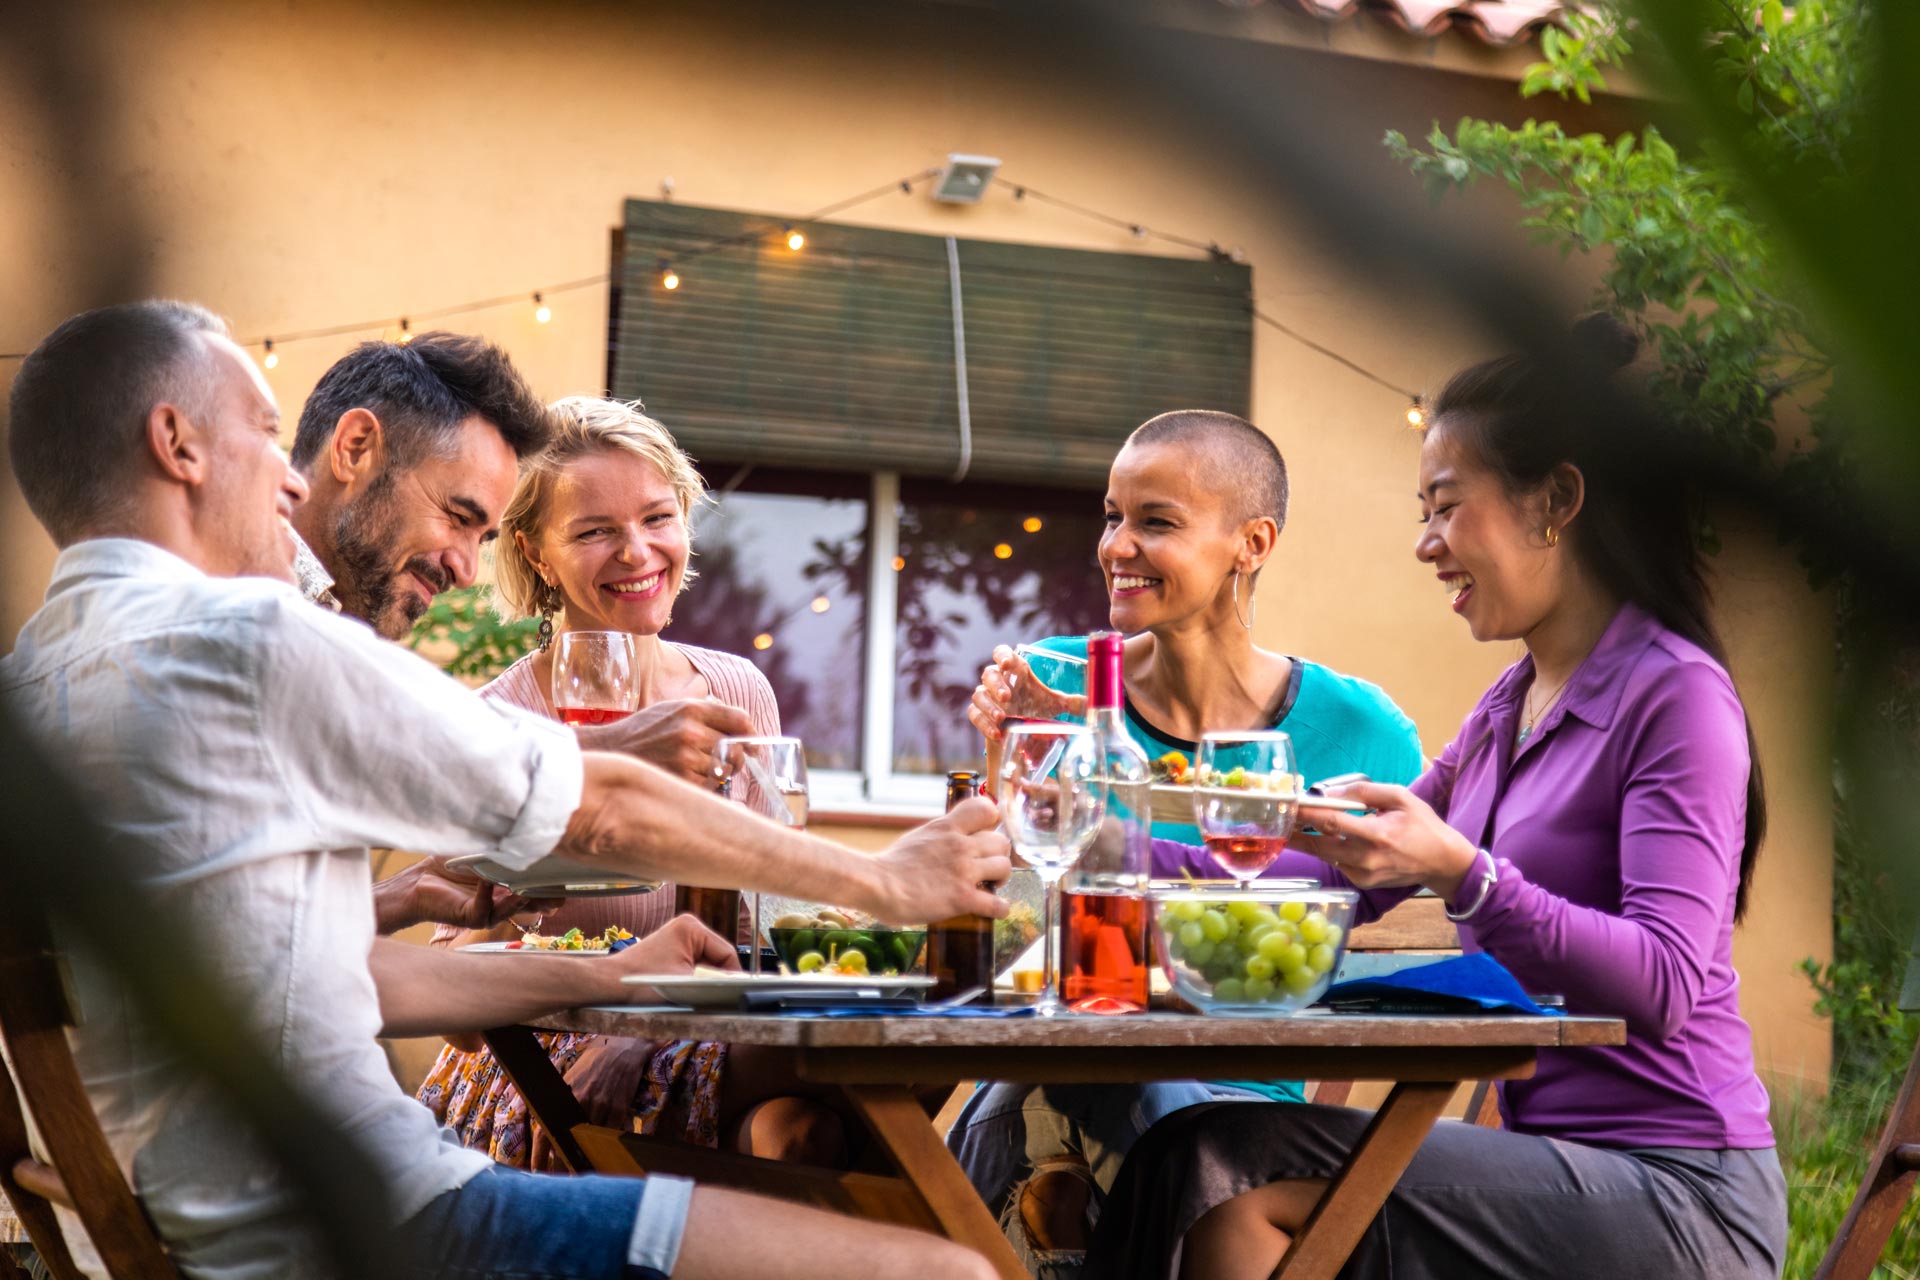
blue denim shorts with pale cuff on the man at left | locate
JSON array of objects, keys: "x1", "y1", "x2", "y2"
[{"x1": 396, "y1": 1169, "x2": 693, "y2": 1280}]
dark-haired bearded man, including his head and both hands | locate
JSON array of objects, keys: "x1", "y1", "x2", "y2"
[{"x1": 292, "y1": 332, "x2": 753, "y2": 933}]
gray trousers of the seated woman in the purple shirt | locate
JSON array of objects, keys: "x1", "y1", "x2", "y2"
[{"x1": 1085, "y1": 1103, "x2": 1788, "y2": 1280}]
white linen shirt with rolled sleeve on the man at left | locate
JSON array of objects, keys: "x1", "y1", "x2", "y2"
[{"x1": 0, "y1": 539, "x2": 584, "y2": 1280}]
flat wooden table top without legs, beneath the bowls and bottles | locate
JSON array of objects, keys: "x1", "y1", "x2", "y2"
[{"x1": 530, "y1": 1007, "x2": 1626, "y2": 1050}]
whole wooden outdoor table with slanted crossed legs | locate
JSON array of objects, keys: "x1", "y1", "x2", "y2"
[{"x1": 488, "y1": 1009, "x2": 1626, "y2": 1280}]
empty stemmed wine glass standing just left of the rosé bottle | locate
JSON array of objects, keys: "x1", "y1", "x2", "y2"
[{"x1": 1000, "y1": 723, "x2": 1106, "y2": 1017}]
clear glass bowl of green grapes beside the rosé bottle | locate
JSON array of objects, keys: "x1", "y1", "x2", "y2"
[{"x1": 1152, "y1": 881, "x2": 1359, "y2": 1017}]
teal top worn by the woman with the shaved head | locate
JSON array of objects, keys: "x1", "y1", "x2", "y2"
[{"x1": 1035, "y1": 635, "x2": 1427, "y2": 1102}]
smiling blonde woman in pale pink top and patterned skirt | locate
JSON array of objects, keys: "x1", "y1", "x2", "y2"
[{"x1": 419, "y1": 395, "x2": 845, "y2": 1169}]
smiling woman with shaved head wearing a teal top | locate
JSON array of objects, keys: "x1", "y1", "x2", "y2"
[{"x1": 948, "y1": 409, "x2": 1421, "y2": 1276}]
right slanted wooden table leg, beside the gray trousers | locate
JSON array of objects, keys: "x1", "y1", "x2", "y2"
[{"x1": 1273, "y1": 1080, "x2": 1457, "y2": 1280}]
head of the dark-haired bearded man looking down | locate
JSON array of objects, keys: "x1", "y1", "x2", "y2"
[{"x1": 294, "y1": 332, "x2": 551, "y2": 639}]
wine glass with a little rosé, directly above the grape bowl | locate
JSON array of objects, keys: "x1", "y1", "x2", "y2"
[{"x1": 1194, "y1": 729, "x2": 1300, "y2": 885}]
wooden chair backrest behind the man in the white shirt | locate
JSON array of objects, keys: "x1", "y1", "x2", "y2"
[{"x1": 0, "y1": 917, "x2": 179, "y2": 1280}]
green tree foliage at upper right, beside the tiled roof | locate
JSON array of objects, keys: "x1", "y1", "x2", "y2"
[{"x1": 1386, "y1": 0, "x2": 1864, "y2": 581}]
